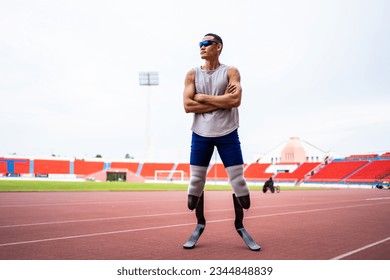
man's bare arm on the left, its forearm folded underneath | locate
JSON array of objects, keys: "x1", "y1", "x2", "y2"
[{"x1": 183, "y1": 70, "x2": 218, "y2": 114}]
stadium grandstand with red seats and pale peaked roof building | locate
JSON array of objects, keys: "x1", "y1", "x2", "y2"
[{"x1": 0, "y1": 137, "x2": 390, "y2": 187}]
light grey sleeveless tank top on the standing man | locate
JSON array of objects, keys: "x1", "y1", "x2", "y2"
[{"x1": 192, "y1": 64, "x2": 239, "y2": 137}]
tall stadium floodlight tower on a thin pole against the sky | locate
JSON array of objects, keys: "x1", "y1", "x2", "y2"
[{"x1": 139, "y1": 72, "x2": 159, "y2": 161}]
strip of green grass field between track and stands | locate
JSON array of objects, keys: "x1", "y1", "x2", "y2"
[{"x1": 0, "y1": 180, "x2": 330, "y2": 192}]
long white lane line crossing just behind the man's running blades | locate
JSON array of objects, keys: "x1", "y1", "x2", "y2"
[{"x1": 0, "y1": 202, "x2": 390, "y2": 247}]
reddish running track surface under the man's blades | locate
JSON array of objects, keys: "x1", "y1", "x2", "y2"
[{"x1": 0, "y1": 189, "x2": 390, "y2": 260}]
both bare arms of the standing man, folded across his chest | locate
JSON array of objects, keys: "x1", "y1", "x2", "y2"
[{"x1": 183, "y1": 67, "x2": 242, "y2": 113}]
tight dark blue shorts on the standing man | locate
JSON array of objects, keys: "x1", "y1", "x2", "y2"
[{"x1": 190, "y1": 129, "x2": 244, "y2": 167}]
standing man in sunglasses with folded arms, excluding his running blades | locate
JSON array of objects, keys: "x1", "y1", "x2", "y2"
[{"x1": 183, "y1": 33, "x2": 250, "y2": 210}]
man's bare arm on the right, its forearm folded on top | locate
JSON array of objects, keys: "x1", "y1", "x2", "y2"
[{"x1": 194, "y1": 67, "x2": 242, "y2": 109}]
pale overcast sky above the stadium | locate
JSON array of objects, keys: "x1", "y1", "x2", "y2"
[{"x1": 0, "y1": 0, "x2": 390, "y2": 162}]
